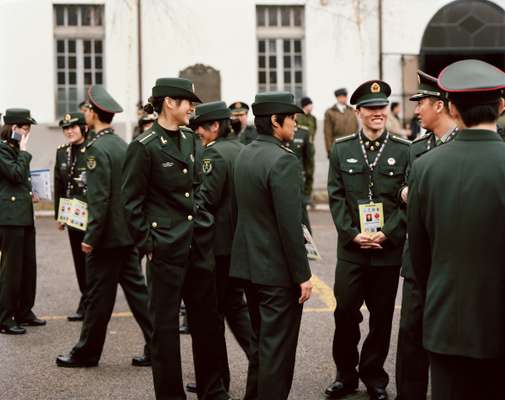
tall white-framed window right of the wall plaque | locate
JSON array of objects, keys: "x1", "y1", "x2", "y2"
[{"x1": 256, "y1": 6, "x2": 305, "y2": 100}]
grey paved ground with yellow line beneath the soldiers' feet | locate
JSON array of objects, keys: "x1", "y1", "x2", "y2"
[{"x1": 0, "y1": 211, "x2": 418, "y2": 400}]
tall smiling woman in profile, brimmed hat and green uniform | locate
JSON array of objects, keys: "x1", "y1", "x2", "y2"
[{"x1": 123, "y1": 78, "x2": 229, "y2": 400}]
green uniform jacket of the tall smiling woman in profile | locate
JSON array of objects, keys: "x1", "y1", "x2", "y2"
[{"x1": 122, "y1": 122, "x2": 197, "y2": 266}]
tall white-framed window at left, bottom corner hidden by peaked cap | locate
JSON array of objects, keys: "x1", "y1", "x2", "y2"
[{"x1": 54, "y1": 4, "x2": 105, "y2": 118}]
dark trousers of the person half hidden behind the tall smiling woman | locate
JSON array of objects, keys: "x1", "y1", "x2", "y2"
[{"x1": 216, "y1": 255, "x2": 252, "y2": 390}]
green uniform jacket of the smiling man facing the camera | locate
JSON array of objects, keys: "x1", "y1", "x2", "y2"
[{"x1": 328, "y1": 133, "x2": 410, "y2": 266}]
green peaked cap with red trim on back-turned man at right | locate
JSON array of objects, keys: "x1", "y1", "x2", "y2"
[{"x1": 438, "y1": 59, "x2": 505, "y2": 104}]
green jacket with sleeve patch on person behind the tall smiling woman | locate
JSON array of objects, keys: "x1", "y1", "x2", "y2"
[{"x1": 198, "y1": 139, "x2": 244, "y2": 256}]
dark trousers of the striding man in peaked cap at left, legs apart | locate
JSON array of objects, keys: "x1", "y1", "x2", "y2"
[{"x1": 72, "y1": 246, "x2": 152, "y2": 362}]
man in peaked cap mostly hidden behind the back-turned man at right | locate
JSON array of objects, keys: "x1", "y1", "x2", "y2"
[{"x1": 396, "y1": 71, "x2": 457, "y2": 400}]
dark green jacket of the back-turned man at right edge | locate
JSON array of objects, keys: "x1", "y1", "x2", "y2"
[{"x1": 408, "y1": 130, "x2": 505, "y2": 359}]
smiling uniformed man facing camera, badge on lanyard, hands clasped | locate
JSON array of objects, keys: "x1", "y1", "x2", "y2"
[{"x1": 325, "y1": 80, "x2": 410, "y2": 400}]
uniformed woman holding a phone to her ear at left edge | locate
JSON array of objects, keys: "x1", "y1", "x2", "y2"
[{"x1": 0, "y1": 108, "x2": 46, "y2": 335}]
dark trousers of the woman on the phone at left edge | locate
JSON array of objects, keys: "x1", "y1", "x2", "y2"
[{"x1": 0, "y1": 226, "x2": 37, "y2": 326}]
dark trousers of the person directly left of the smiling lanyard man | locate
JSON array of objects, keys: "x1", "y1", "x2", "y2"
[{"x1": 244, "y1": 283, "x2": 303, "y2": 400}]
